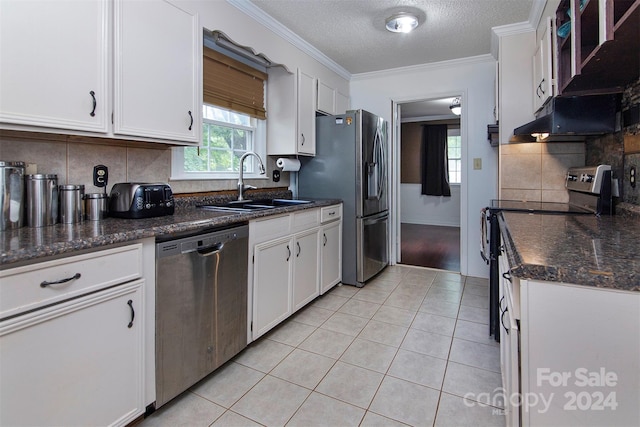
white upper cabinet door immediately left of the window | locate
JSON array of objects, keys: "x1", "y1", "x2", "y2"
[{"x1": 114, "y1": 0, "x2": 202, "y2": 143}]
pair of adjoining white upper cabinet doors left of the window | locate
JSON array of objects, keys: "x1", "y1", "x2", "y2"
[{"x1": 0, "y1": 0, "x2": 202, "y2": 144}]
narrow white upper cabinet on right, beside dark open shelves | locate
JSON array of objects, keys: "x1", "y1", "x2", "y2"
[{"x1": 533, "y1": 17, "x2": 555, "y2": 112}]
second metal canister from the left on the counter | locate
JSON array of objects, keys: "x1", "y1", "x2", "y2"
[{"x1": 24, "y1": 174, "x2": 58, "y2": 227}]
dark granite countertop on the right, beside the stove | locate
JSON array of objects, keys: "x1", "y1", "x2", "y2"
[{"x1": 498, "y1": 212, "x2": 640, "y2": 291}]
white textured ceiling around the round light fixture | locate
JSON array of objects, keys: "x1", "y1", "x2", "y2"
[{"x1": 251, "y1": 0, "x2": 539, "y2": 74}]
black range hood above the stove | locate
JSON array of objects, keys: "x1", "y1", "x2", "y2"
[{"x1": 513, "y1": 94, "x2": 620, "y2": 142}]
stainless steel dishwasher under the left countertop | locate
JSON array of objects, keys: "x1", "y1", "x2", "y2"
[{"x1": 156, "y1": 225, "x2": 249, "y2": 408}]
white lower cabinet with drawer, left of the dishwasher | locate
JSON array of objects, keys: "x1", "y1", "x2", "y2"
[{"x1": 0, "y1": 243, "x2": 146, "y2": 426}]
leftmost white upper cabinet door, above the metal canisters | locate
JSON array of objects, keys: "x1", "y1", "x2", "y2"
[{"x1": 0, "y1": 0, "x2": 110, "y2": 133}]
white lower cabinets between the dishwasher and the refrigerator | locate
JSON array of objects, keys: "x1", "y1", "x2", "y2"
[{"x1": 247, "y1": 205, "x2": 342, "y2": 342}]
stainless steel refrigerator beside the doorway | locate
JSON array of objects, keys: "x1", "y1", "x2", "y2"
[{"x1": 298, "y1": 110, "x2": 389, "y2": 287}]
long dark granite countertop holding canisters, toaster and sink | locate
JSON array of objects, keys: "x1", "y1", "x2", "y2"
[{"x1": 0, "y1": 199, "x2": 342, "y2": 269}]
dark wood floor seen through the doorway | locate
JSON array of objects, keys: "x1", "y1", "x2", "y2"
[{"x1": 400, "y1": 223, "x2": 460, "y2": 271}]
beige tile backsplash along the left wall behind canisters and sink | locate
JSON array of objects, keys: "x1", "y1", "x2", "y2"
[{"x1": 0, "y1": 131, "x2": 289, "y2": 194}]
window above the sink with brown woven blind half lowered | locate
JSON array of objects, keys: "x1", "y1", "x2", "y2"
[{"x1": 171, "y1": 47, "x2": 267, "y2": 179}]
